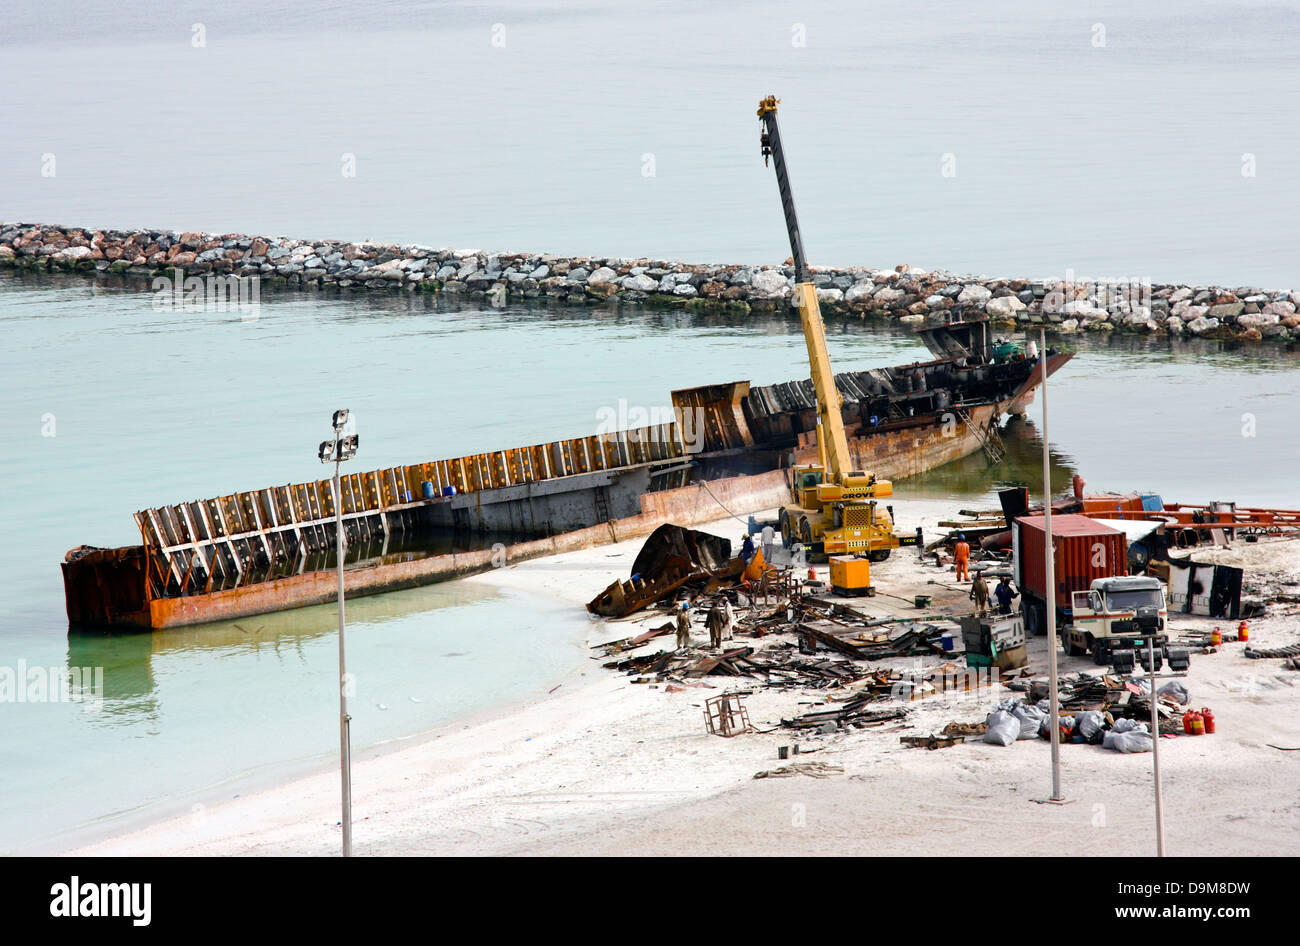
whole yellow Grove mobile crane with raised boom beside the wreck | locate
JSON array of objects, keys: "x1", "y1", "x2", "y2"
[{"x1": 758, "y1": 95, "x2": 920, "y2": 561}]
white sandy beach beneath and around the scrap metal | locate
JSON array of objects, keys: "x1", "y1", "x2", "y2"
[{"x1": 68, "y1": 498, "x2": 1300, "y2": 855}]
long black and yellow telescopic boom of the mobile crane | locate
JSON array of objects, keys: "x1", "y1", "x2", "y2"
[{"x1": 758, "y1": 95, "x2": 853, "y2": 482}]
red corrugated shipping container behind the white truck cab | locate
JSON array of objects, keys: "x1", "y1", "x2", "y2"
[{"x1": 1011, "y1": 515, "x2": 1128, "y2": 608}]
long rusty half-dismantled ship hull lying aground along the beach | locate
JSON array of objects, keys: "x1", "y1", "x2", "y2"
[{"x1": 62, "y1": 314, "x2": 1071, "y2": 629}]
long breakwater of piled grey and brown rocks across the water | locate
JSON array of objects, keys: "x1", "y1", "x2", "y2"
[{"x1": 0, "y1": 222, "x2": 1300, "y2": 342}]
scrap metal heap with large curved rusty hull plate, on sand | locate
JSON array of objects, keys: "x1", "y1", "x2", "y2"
[{"x1": 589, "y1": 526, "x2": 997, "y2": 732}]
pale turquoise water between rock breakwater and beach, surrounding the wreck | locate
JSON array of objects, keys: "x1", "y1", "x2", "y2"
[{"x1": 0, "y1": 277, "x2": 1300, "y2": 850}]
